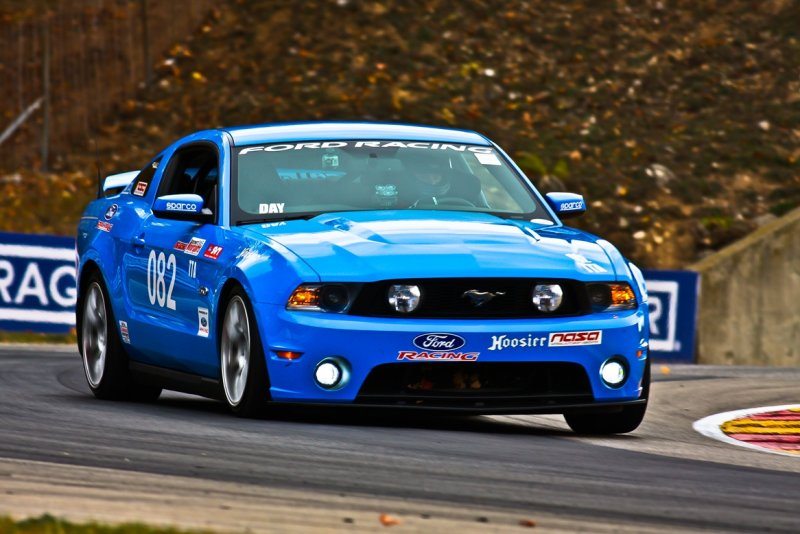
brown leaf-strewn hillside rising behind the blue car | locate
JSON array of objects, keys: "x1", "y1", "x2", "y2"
[{"x1": 0, "y1": 0, "x2": 800, "y2": 267}]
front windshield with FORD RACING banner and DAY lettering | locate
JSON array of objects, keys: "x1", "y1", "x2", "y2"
[{"x1": 232, "y1": 140, "x2": 551, "y2": 223}]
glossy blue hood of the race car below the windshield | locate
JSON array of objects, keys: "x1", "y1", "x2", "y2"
[{"x1": 247, "y1": 210, "x2": 618, "y2": 282}]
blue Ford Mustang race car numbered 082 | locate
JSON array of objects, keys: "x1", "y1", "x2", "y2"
[{"x1": 77, "y1": 122, "x2": 650, "y2": 433}]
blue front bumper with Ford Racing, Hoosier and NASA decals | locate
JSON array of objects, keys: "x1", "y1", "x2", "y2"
[{"x1": 255, "y1": 303, "x2": 648, "y2": 413}]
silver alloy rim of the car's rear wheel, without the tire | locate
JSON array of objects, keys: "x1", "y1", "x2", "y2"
[{"x1": 81, "y1": 282, "x2": 108, "y2": 389}]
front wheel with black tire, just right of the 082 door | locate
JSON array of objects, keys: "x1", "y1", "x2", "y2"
[{"x1": 219, "y1": 286, "x2": 270, "y2": 418}]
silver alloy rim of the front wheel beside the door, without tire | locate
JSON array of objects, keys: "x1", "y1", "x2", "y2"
[{"x1": 220, "y1": 295, "x2": 250, "y2": 406}]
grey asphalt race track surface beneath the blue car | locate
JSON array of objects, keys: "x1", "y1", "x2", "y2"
[{"x1": 0, "y1": 347, "x2": 800, "y2": 532}]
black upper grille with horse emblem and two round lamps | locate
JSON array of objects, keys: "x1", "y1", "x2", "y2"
[{"x1": 350, "y1": 278, "x2": 590, "y2": 319}]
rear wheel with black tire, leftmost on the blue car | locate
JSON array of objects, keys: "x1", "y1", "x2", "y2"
[{"x1": 78, "y1": 272, "x2": 161, "y2": 402}]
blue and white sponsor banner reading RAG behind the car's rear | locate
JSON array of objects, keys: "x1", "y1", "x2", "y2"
[{"x1": 0, "y1": 233, "x2": 77, "y2": 333}]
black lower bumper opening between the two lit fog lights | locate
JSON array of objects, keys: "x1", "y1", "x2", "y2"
[{"x1": 356, "y1": 362, "x2": 594, "y2": 407}]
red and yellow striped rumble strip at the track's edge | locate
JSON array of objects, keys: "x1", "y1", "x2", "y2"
[{"x1": 720, "y1": 408, "x2": 800, "y2": 456}]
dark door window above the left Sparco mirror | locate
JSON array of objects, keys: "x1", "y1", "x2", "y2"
[{"x1": 158, "y1": 145, "x2": 219, "y2": 221}]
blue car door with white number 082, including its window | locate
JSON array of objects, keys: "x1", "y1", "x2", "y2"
[{"x1": 124, "y1": 143, "x2": 221, "y2": 376}]
